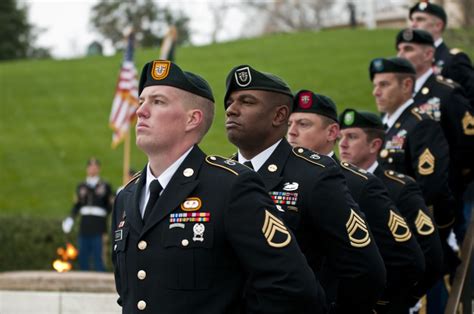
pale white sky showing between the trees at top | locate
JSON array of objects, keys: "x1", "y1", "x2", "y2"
[{"x1": 25, "y1": 0, "x2": 248, "y2": 58}]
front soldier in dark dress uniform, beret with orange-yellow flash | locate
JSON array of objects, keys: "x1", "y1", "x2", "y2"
[{"x1": 112, "y1": 60, "x2": 325, "y2": 314}]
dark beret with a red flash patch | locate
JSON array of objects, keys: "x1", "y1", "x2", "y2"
[{"x1": 293, "y1": 90, "x2": 337, "y2": 122}]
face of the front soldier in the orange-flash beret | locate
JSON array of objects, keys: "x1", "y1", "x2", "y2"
[{"x1": 136, "y1": 85, "x2": 187, "y2": 154}]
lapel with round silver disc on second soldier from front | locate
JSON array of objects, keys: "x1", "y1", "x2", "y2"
[{"x1": 258, "y1": 138, "x2": 292, "y2": 191}]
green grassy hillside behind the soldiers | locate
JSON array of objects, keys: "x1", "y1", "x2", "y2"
[{"x1": 0, "y1": 30, "x2": 472, "y2": 216}]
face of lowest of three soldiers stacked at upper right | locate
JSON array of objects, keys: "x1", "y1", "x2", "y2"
[{"x1": 372, "y1": 73, "x2": 404, "y2": 114}]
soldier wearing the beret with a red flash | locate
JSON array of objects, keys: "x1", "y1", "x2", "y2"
[{"x1": 287, "y1": 90, "x2": 425, "y2": 313}]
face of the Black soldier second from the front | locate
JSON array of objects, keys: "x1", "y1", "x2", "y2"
[{"x1": 225, "y1": 90, "x2": 282, "y2": 148}]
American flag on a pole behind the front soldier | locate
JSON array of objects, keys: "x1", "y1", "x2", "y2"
[{"x1": 109, "y1": 33, "x2": 138, "y2": 148}]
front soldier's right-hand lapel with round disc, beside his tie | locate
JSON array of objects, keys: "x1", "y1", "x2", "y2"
[{"x1": 142, "y1": 145, "x2": 202, "y2": 234}]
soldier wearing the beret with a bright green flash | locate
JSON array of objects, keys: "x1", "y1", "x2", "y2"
[{"x1": 339, "y1": 109, "x2": 443, "y2": 313}]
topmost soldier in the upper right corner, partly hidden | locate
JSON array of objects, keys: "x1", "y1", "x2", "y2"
[{"x1": 409, "y1": 1, "x2": 474, "y2": 107}]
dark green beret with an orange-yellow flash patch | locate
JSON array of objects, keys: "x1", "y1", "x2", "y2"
[{"x1": 138, "y1": 60, "x2": 214, "y2": 101}]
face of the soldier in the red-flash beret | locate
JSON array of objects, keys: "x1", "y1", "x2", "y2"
[{"x1": 287, "y1": 112, "x2": 337, "y2": 154}]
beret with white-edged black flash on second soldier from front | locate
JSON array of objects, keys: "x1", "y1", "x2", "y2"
[{"x1": 224, "y1": 65, "x2": 293, "y2": 109}]
